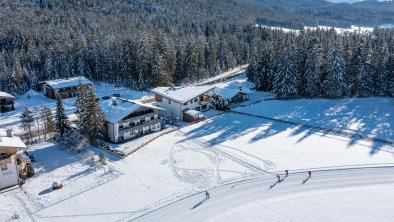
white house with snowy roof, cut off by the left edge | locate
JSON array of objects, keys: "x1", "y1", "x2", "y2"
[{"x1": 0, "y1": 132, "x2": 27, "y2": 190}]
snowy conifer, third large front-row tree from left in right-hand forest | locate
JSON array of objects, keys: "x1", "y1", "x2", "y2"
[{"x1": 322, "y1": 49, "x2": 347, "y2": 98}]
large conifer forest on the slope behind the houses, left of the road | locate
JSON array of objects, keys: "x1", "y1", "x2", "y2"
[{"x1": 0, "y1": 0, "x2": 394, "y2": 95}]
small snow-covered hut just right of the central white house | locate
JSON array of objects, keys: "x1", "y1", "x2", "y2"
[{"x1": 215, "y1": 87, "x2": 251, "y2": 106}]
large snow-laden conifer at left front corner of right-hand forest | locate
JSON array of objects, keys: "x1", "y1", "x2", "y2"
[{"x1": 274, "y1": 48, "x2": 298, "y2": 99}]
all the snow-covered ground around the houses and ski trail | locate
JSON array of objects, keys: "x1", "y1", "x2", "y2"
[{"x1": 0, "y1": 75, "x2": 394, "y2": 222}]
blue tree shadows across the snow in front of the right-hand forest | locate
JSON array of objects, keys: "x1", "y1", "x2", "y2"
[{"x1": 181, "y1": 98, "x2": 394, "y2": 156}]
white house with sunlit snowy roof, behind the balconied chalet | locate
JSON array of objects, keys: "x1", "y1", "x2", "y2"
[{"x1": 151, "y1": 86, "x2": 215, "y2": 121}]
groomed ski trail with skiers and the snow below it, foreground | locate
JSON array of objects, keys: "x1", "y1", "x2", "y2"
[{"x1": 133, "y1": 165, "x2": 394, "y2": 222}]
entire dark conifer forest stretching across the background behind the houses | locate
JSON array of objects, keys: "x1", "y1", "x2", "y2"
[{"x1": 0, "y1": 0, "x2": 394, "y2": 98}]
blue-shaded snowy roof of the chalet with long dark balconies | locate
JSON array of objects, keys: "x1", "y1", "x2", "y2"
[{"x1": 101, "y1": 97, "x2": 164, "y2": 123}]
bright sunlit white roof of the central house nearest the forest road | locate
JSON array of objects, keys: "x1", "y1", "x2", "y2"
[{"x1": 151, "y1": 86, "x2": 215, "y2": 103}]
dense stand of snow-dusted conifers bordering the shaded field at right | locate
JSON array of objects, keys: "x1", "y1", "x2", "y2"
[{"x1": 247, "y1": 28, "x2": 394, "y2": 99}]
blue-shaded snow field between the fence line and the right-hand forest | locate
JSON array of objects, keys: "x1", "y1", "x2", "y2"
[{"x1": 236, "y1": 97, "x2": 394, "y2": 149}]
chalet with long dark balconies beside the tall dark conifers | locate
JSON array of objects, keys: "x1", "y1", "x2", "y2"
[{"x1": 101, "y1": 98, "x2": 163, "y2": 143}]
